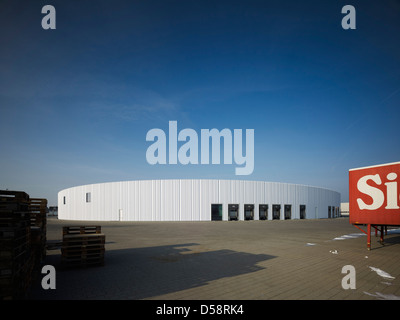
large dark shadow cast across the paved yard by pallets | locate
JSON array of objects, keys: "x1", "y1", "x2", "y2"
[{"x1": 28, "y1": 243, "x2": 275, "y2": 300}]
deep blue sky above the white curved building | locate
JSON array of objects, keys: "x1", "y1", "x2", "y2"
[{"x1": 0, "y1": 0, "x2": 400, "y2": 205}]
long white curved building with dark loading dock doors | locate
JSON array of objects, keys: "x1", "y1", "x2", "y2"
[{"x1": 58, "y1": 179, "x2": 340, "y2": 221}]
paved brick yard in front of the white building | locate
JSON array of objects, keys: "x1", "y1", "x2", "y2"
[{"x1": 29, "y1": 218, "x2": 400, "y2": 300}]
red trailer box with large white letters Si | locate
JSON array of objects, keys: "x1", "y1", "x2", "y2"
[{"x1": 349, "y1": 162, "x2": 400, "y2": 225}]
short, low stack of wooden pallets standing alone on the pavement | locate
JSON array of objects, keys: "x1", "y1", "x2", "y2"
[{"x1": 61, "y1": 226, "x2": 105, "y2": 267}]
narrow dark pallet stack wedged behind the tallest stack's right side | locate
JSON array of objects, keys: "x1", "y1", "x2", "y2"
[{"x1": 28, "y1": 198, "x2": 47, "y2": 274}]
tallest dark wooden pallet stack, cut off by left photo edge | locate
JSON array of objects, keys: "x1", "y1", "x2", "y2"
[{"x1": 0, "y1": 190, "x2": 34, "y2": 300}]
